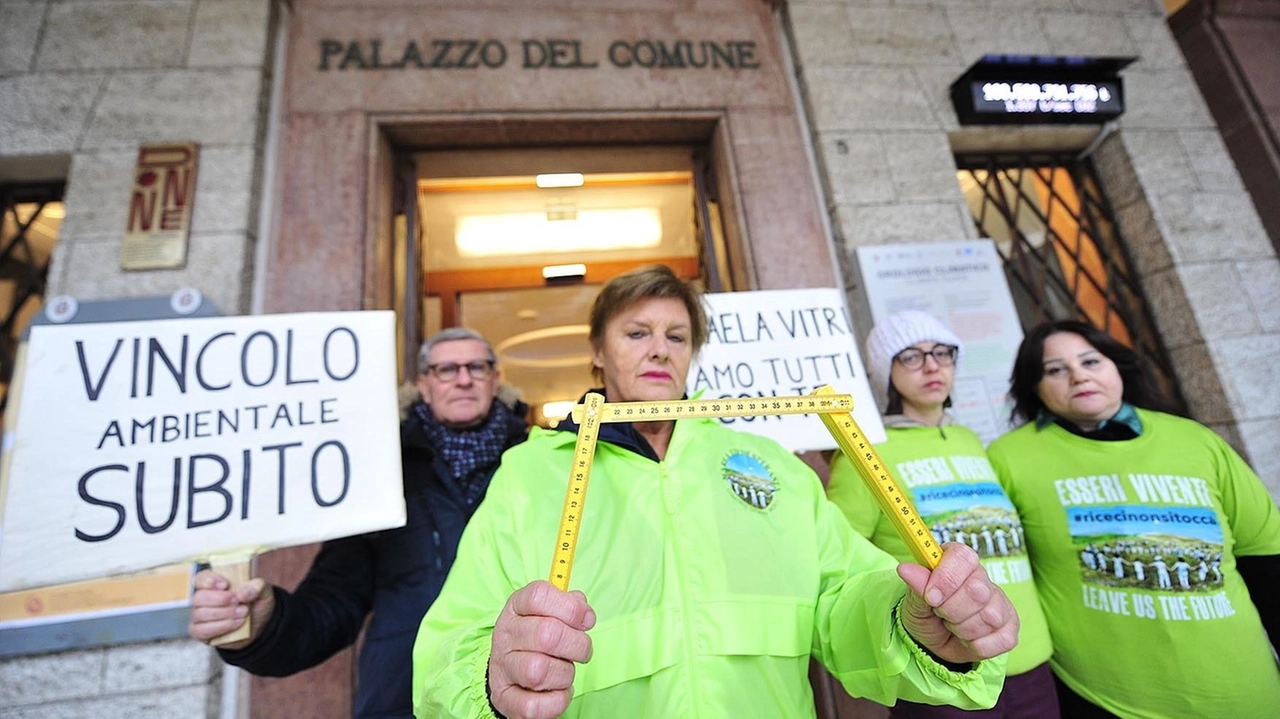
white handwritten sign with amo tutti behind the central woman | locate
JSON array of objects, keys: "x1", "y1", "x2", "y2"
[{"x1": 686, "y1": 288, "x2": 884, "y2": 452}]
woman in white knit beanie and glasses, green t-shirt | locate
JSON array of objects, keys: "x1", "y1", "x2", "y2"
[{"x1": 827, "y1": 310, "x2": 1060, "y2": 719}]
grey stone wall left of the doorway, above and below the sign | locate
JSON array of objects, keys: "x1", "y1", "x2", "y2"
[{"x1": 0, "y1": 0, "x2": 278, "y2": 719}]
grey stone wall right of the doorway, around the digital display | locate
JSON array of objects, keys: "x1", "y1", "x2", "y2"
[{"x1": 787, "y1": 0, "x2": 1280, "y2": 495}]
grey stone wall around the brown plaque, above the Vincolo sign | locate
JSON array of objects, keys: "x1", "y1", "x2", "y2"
[{"x1": 0, "y1": 0, "x2": 271, "y2": 313}]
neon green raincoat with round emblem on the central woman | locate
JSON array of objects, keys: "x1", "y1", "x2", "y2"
[{"x1": 413, "y1": 411, "x2": 1005, "y2": 719}]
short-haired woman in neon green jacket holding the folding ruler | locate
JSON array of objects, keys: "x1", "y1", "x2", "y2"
[{"x1": 413, "y1": 266, "x2": 1018, "y2": 719}]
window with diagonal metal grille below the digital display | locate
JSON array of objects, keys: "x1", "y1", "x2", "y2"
[{"x1": 956, "y1": 155, "x2": 1185, "y2": 411}]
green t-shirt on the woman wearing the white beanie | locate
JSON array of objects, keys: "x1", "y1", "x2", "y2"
[{"x1": 827, "y1": 425, "x2": 1053, "y2": 676}]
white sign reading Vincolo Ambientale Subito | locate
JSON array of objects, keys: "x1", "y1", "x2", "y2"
[{"x1": 0, "y1": 311, "x2": 404, "y2": 591}]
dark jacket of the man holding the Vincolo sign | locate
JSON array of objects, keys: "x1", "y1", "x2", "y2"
[{"x1": 220, "y1": 400, "x2": 526, "y2": 719}]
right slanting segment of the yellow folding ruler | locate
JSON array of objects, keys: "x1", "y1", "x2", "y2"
[{"x1": 813, "y1": 386, "x2": 942, "y2": 569}]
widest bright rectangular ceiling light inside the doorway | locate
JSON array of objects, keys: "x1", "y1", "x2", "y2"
[{"x1": 453, "y1": 207, "x2": 662, "y2": 257}]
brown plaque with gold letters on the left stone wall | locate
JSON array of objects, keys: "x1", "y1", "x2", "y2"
[{"x1": 120, "y1": 142, "x2": 200, "y2": 270}]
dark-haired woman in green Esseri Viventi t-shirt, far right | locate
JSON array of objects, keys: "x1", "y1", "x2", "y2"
[{"x1": 987, "y1": 321, "x2": 1280, "y2": 719}]
